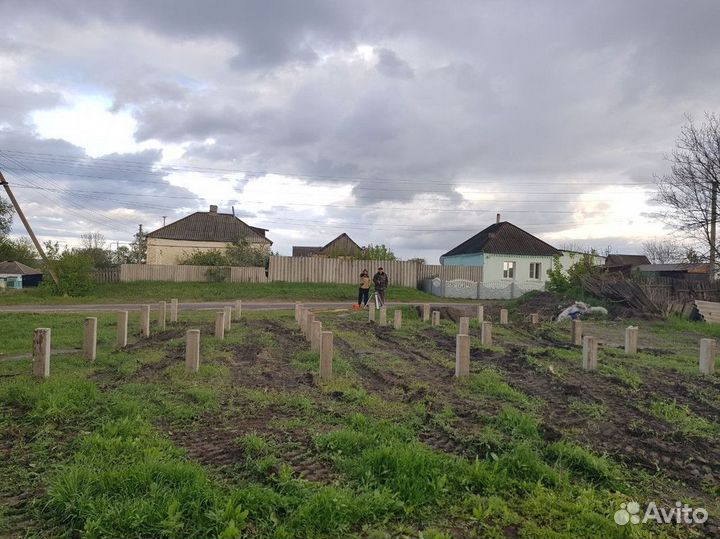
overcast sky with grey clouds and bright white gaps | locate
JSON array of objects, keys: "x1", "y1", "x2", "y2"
[{"x1": 0, "y1": 0, "x2": 720, "y2": 263}]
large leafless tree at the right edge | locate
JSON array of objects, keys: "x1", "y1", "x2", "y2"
[{"x1": 655, "y1": 112, "x2": 720, "y2": 275}]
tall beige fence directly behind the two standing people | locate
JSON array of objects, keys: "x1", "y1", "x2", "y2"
[{"x1": 268, "y1": 256, "x2": 482, "y2": 288}]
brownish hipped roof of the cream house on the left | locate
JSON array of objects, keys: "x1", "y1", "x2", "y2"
[{"x1": 147, "y1": 211, "x2": 272, "y2": 245}]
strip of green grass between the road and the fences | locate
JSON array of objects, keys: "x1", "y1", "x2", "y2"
[{"x1": 0, "y1": 281, "x2": 438, "y2": 305}]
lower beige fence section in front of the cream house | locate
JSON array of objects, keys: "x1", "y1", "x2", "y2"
[{"x1": 119, "y1": 264, "x2": 267, "y2": 283}]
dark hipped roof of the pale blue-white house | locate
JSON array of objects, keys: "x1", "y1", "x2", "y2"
[{"x1": 442, "y1": 221, "x2": 561, "y2": 257}]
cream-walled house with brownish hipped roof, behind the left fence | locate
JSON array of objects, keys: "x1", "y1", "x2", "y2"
[{"x1": 146, "y1": 205, "x2": 272, "y2": 265}]
